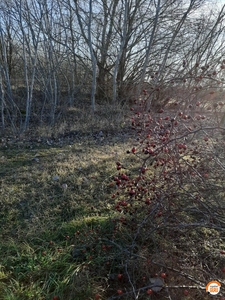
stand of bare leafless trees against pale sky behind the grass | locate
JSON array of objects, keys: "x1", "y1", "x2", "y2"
[{"x1": 0, "y1": 0, "x2": 225, "y2": 133}]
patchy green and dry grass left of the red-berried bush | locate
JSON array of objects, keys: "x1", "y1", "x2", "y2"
[{"x1": 0, "y1": 106, "x2": 135, "y2": 300}]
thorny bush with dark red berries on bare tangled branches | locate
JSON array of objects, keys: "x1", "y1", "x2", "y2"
[{"x1": 110, "y1": 91, "x2": 225, "y2": 299}]
